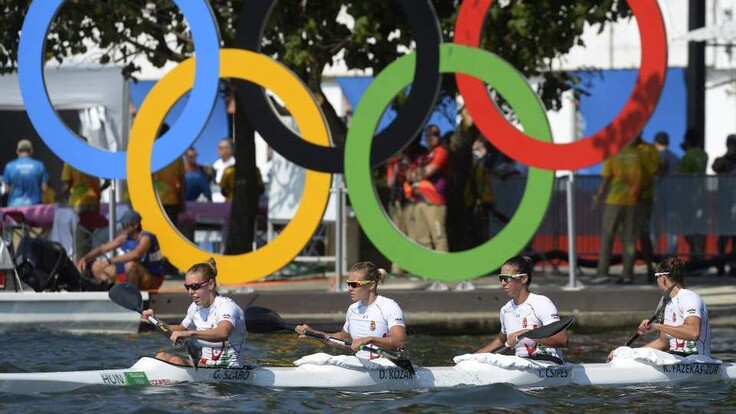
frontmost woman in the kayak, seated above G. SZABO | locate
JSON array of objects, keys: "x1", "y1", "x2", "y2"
[{"x1": 141, "y1": 259, "x2": 246, "y2": 368}]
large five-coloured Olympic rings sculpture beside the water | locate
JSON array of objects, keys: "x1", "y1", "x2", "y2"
[{"x1": 18, "y1": 0, "x2": 667, "y2": 284}]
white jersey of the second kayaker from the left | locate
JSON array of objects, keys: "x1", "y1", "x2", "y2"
[{"x1": 342, "y1": 295, "x2": 406, "y2": 339}]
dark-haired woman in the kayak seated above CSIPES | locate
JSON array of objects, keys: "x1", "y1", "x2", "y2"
[{"x1": 477, "y1": 256, "x2": 567, "y2": 364}]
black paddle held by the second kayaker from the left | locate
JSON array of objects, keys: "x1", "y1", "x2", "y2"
[{"x1": 245, "y1": 306, "x2": 416, "y2": 375}]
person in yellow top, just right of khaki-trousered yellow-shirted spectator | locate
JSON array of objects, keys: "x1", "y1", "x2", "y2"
[{"x1": 633, "y1": 134, "x2": 660, "y2": 283}]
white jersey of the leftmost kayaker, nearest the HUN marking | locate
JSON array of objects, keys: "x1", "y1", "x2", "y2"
[{"x1": 181, "y1": 295, "x2": 246, "y2": 368}]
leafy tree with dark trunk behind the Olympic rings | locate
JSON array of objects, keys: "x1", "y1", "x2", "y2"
[{"x1": 0, "y1": 0, "x2": 630, "y2": 253}]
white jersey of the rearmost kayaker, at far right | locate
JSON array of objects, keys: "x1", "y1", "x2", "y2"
[{"x1": 663, "y1": 289, "x2": 712, "y2": 356}]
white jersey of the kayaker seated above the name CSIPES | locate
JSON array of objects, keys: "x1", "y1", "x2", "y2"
[{"x1": 500, "y1": 293, "x2": 563, "y2": 359}]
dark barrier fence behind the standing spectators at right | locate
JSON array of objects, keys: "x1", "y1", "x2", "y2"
[{"x1": 493, "y1": 175, "x2": 736, "y2": 260}]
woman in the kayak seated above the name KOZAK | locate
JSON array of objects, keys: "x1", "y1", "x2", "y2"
[{"x1": 296, "y1": 262, "x2": 406, "y2": 352}]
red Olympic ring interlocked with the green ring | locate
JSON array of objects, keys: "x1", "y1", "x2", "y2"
[{"x1": 455, "y1": 0, "x2": 667, "y2": 170}]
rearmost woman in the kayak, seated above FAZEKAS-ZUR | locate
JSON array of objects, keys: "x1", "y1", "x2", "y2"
[{"x1": 624, "y1": 257, "x2": 712, "y2": 356}]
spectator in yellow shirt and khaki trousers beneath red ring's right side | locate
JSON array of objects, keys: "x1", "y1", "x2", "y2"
[{"x1": 591, "y1": 141, "x2": 643, "y2": 284}]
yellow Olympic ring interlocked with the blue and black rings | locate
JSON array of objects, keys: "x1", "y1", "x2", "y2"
[{"x1": 127, "y1": 49, "x2": 332, "y2": 284}]
